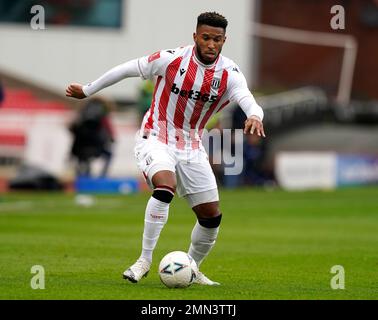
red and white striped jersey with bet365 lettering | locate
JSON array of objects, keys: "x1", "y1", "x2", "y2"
[{"x1": 137, "y1": 45, "x2": 262, "y2": 149}]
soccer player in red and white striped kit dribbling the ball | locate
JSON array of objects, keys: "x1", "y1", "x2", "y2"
[{"x1": 66, "y1": 12, "x2": 265, "y2": 285}]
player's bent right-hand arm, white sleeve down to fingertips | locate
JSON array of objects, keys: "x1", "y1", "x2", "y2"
[{"x1": 230, "y1": 68, "x2": 265, "y2": 138}]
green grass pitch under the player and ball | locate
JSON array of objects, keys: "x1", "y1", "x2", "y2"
[{"x1": 0, "y1": 187, "x2": 378, "y2": 300}]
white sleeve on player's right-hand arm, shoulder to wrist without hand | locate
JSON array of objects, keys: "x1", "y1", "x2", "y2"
[{"x1": 229, "y1": 66, "x2": 264, "y2": 121}]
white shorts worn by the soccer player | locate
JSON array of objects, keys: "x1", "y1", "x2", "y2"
[{"x1": 134, "y1": 135, "x2": 219, "y2": 204}]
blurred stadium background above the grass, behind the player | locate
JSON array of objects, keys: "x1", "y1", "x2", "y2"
[{"x1": 0, "y1": 0, "x2": 378, "y2": 298}]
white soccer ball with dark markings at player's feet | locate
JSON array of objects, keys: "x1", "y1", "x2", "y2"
[{"x1": 159, "y1": 251, "x2": 198, "y2": 288}]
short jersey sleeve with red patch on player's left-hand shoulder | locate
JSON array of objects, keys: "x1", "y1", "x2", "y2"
[{"x1": 138, "y1": 49, "x2": 177, "y2": 79}]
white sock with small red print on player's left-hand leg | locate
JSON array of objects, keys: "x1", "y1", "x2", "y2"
[{"x1": 141, "y1": 197, "x2": 169, "y2": 262}]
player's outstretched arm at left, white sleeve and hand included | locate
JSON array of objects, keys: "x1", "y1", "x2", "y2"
[{"x1": 66, "y1": 50, "x2": 172, "y2": 99}]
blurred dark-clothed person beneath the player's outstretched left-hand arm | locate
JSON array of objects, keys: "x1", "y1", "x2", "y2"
[{"x1": 69, "y1": 97, "x2": 115, "y2": 177}]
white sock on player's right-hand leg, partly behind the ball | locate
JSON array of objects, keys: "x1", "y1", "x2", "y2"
[{"x1": 188, "y1": 221, "x2": 219, "y2": 267}]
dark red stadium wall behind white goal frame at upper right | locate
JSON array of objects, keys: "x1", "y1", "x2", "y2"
[{"x1": 258, "y1": 0, "x2": 378, "y2": 99}]
